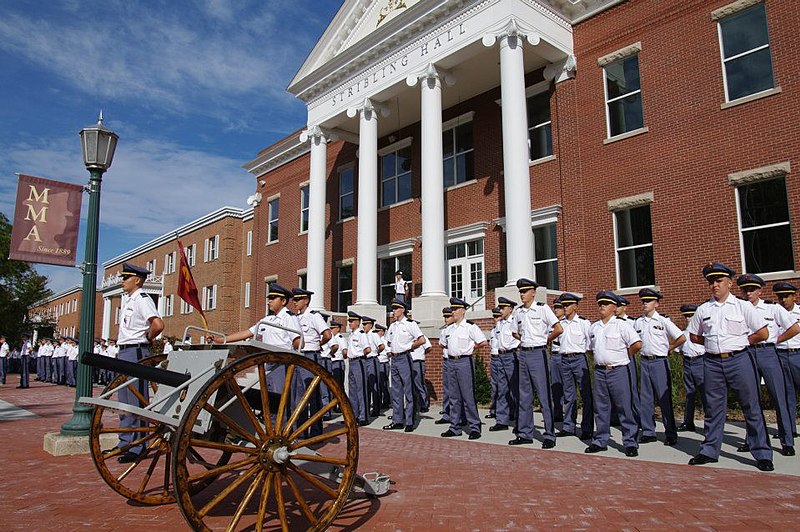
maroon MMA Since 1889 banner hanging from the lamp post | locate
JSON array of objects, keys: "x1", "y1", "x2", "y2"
[{"x1": 8, "y1": 174, "x2": 83, "y2": 266}]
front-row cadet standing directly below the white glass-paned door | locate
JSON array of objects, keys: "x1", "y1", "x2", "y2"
[{"x1": 442, "y1": 297, "x2": 486, "y2": 440}]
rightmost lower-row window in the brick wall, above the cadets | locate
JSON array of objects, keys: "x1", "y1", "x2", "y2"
[{"x1": 736, "y1": 177, "x2": 794, "y2": 273}]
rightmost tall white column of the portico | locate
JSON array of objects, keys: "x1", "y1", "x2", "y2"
[{"x1": 483, "y1": 19, "x2": 539, "y2": 286}]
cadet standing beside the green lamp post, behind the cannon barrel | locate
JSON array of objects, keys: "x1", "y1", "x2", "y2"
[{"x1": 113, "y1": 262, "x2": 164, "y2": 463}]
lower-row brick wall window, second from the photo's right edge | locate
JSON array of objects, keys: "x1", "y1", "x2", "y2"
[{"x1": 614, "y1": 205, "x2": 656, "y2": 288}]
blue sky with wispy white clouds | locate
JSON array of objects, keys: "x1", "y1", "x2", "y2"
[{"x1": 0, "y1": 0, "x2": 341, "y2": 292}]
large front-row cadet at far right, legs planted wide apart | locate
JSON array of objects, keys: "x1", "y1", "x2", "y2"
[{"x1": 689, "y1": 262, "x2": 775, "y2": 471}]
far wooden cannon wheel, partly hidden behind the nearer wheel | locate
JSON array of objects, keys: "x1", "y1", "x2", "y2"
[{"x1": 89, "y1": 355, "x2": 229, "y2": 505}]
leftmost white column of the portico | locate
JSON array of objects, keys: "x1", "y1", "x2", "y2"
[{"x1": 300, "y1": 126, "x2": 328, "y2": 310}]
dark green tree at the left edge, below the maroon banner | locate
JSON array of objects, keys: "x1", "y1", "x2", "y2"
[{"x1": 0, "y1": 213, "x2": 53, "y2": 344}]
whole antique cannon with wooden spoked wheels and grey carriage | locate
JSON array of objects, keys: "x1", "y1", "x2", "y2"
[{"x1": 80, "y1": 322, "x2": 390, "y2": 530}]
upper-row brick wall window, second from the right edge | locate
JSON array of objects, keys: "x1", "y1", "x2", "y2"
[{"x1": 603, "y1": 54, "x2": 644, "y2": 137}]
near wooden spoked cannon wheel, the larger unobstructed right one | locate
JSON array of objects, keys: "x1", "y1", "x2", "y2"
[{"x1": 173, "y1": 352, "x2": 358, "y2": 530}]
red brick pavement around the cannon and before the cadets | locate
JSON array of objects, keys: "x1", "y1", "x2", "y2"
[{"x1": 0, "y1": 375, "x2": 800, "y2": 532}]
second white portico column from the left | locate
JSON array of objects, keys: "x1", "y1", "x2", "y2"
[{"x1": 348, "y1": 98, "x2": 378, "y2": 305}]
